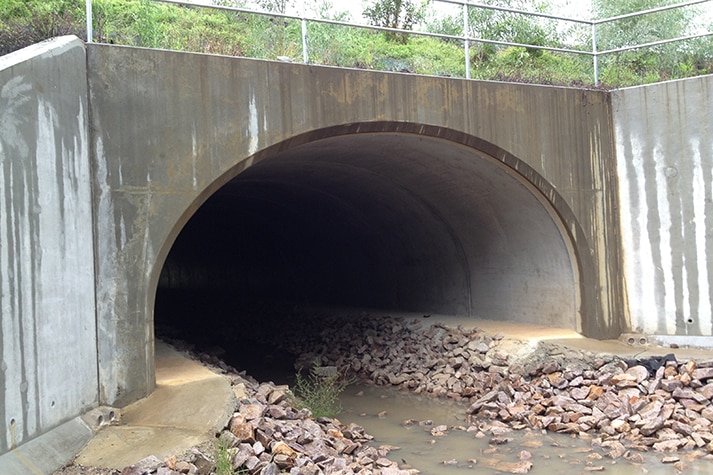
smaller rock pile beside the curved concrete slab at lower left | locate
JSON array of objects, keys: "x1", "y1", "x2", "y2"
[{"x1": 120, "y1": 368, "x2": 418, "y2": 475}]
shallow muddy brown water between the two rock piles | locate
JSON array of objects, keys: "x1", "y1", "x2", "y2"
[{"x1": 338, "y1": 385, "x2": 713, "y2": 475}]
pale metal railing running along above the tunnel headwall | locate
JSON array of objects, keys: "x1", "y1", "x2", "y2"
[{"x1": 86, "y1": 0, "x2": 713, "y2": 85}]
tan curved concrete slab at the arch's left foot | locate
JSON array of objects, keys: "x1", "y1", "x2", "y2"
[{"x1": 75, "y1": 341, "x2": 235, "y2": 469}]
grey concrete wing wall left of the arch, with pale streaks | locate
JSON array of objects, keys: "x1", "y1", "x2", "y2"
[{"x1": 0, "y1": 37, "x2": 98, "y2": 454}]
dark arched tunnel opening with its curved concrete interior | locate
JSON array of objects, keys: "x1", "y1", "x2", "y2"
[{"x1": 154, "y1": 133, "x2": 580, "y2": 384}]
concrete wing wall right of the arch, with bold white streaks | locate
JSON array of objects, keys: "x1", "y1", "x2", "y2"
[{"x1": 612, "y1": 76, "x2": 713, "y2": 343}]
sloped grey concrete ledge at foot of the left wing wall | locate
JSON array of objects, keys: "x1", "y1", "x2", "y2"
[{"x1": 0, "y1": 417, "x2": 94, "y2": 475}]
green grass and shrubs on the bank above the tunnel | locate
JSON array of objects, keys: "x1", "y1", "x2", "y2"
[{"x1": 0, "y1": 0, "x2": 713, "y2": 87}]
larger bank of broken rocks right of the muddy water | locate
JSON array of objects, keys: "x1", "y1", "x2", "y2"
[{"x1": 272, "y1": 316, "x2": 713, "y2": 458}]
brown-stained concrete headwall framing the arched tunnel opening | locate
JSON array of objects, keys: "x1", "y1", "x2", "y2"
[{"x1": 87, "y1": 45, "x2": 626, "y2": 404}]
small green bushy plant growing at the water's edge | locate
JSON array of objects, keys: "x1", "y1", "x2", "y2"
[{"x1": 292, "y1": 364, "x2": 351, "y2": 418}]
